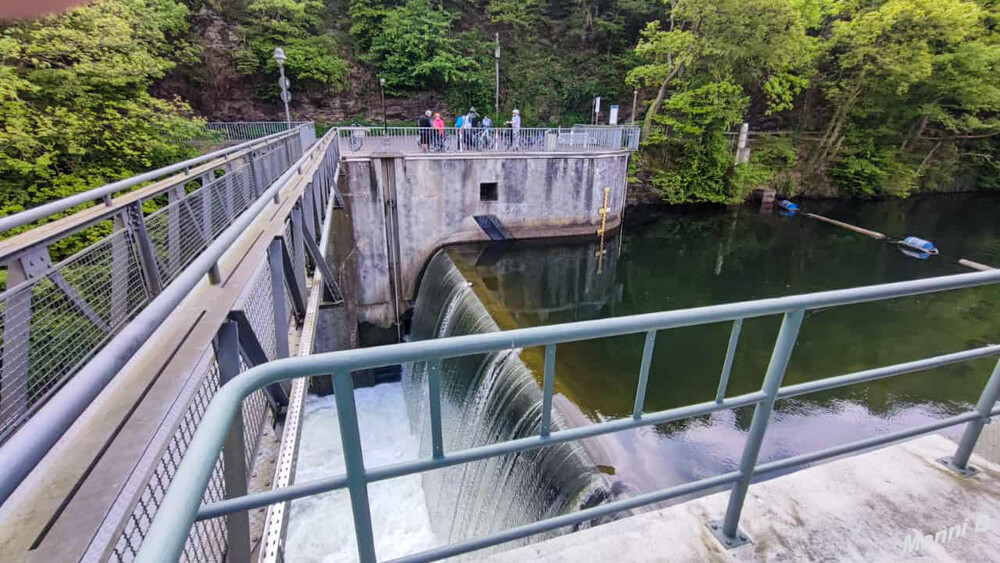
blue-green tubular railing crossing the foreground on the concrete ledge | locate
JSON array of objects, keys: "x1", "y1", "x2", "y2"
[{"x1": 138, "y1": 271, "x2": 1000, "y2": 563}]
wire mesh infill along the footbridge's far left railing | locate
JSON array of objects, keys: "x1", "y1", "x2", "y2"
[{"x1": 0, "y1": 129, "x2": 302, "y2": 442}]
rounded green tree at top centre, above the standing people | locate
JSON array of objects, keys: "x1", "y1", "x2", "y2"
[{"x1": 364, "y1": 0, "x2": 476, "y2": 93}]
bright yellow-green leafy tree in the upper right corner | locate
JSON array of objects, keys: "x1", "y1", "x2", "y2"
[{"x1": 811, "y1": 0, "x2": 1000, "y2": 177}]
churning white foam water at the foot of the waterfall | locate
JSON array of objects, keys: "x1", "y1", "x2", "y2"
[{"x1": 285, "y1": 383, "x2": 442, "y2": 563}]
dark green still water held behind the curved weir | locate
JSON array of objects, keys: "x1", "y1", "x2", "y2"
[{"x1": 449, "y1": 195, "x2": 1000, "y2": 491}]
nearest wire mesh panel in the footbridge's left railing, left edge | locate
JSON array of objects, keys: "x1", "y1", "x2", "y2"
[{"x1": 0, "y1": 230, "x2": 149, "y2": 439}]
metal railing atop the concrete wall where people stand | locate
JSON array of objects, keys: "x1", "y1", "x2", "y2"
[{"x1": 338, "y1": 126, "x2": 640, "y2": 155}]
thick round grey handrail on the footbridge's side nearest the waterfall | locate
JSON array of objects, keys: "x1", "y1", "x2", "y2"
[{"x1": 0, "y1": 131, "x2": 336, "y2": 504}]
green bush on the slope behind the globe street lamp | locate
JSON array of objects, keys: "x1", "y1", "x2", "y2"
[{"x1": 240, "y1": 0, "x2": 348, "y2": 89}]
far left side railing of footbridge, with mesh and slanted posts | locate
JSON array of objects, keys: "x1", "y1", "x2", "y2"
[{"x1": 0, "y1": 126, "x2": 302, "y2": 442}]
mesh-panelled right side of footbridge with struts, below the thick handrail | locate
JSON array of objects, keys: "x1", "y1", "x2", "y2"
[{"x1": 102, "y1": 128, "x2": 342, "y2": 563}]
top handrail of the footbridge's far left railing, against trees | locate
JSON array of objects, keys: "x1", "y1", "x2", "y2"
[{"x1": 0, "y1": 128, "x2": 298, "y2": 233}]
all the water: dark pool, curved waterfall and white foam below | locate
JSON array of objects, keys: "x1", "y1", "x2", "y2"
[{"x1": 286, "y1": 194, "x2": 1000, "y2": 562}]
